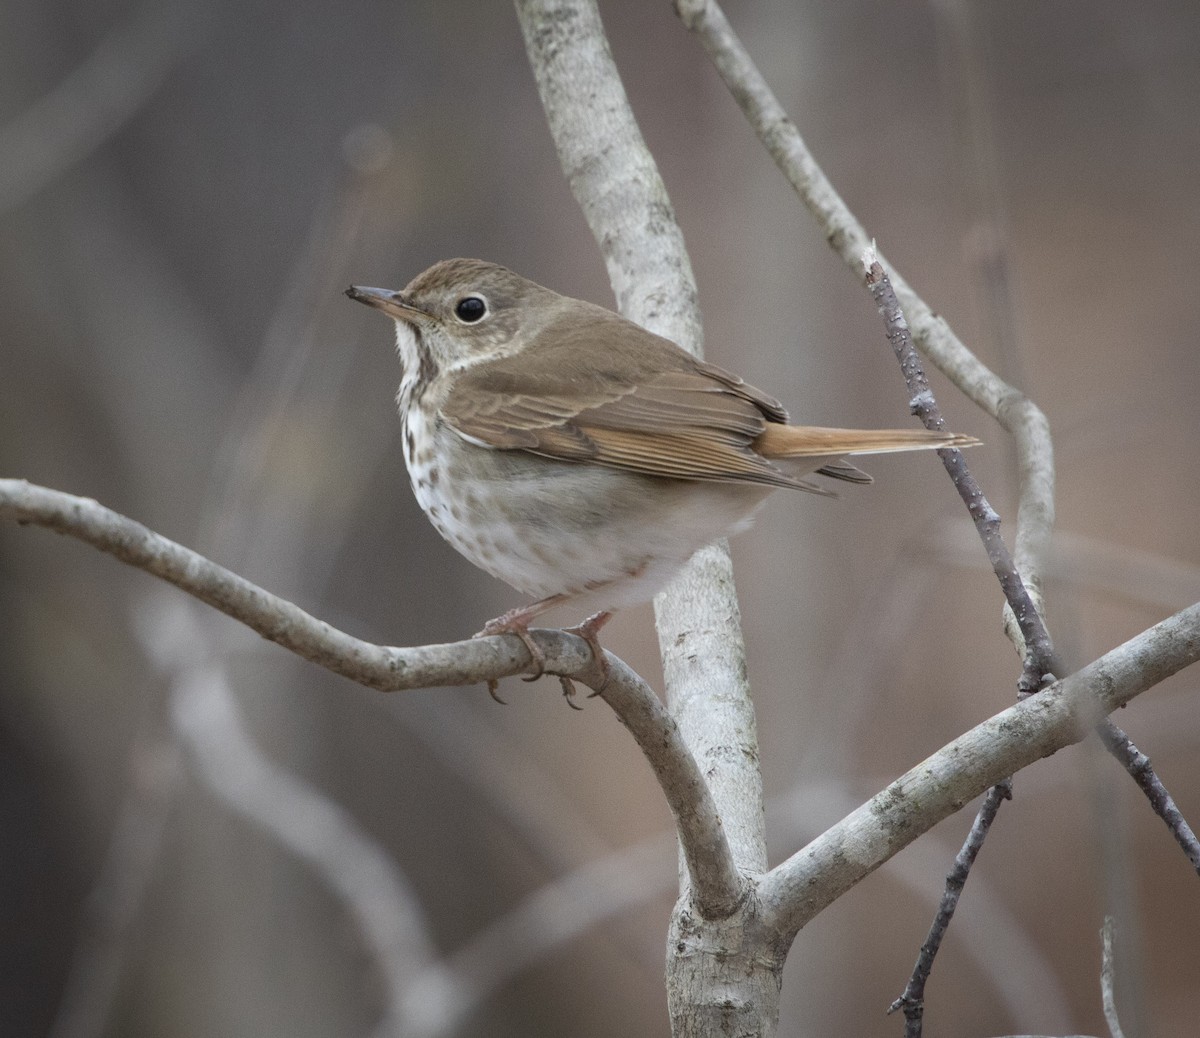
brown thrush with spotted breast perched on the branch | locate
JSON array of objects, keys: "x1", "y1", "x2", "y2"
[{"x1": 346, "y1": 259, "x2": 974, "y2": 691}]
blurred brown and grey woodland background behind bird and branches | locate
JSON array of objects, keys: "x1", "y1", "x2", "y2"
[{"x1": 0, "y1": 0, "x2": 1200, "y2": 1038}]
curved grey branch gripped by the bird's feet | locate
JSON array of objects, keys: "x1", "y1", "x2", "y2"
[{"x1": 0, "y1": 479, "x2": 742, "y2": 904}]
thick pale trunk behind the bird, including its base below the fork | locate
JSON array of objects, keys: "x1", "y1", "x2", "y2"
[{"x1": 516, "y1": 0, "x2": 782, "y2": 1038}]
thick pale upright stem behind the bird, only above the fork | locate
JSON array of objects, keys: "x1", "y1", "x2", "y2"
[{"x1": 516, "y1": 0, "x2": 753, "y2": 918}]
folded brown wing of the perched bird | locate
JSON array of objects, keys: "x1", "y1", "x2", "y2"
[{"x1": 442, "y1": 307, "x2": 821, "y2": 492}]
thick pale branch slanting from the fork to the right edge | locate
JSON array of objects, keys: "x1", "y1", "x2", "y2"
[{"x1": 758, "y1": 604, "x2": 1200, "y2": 947}]
